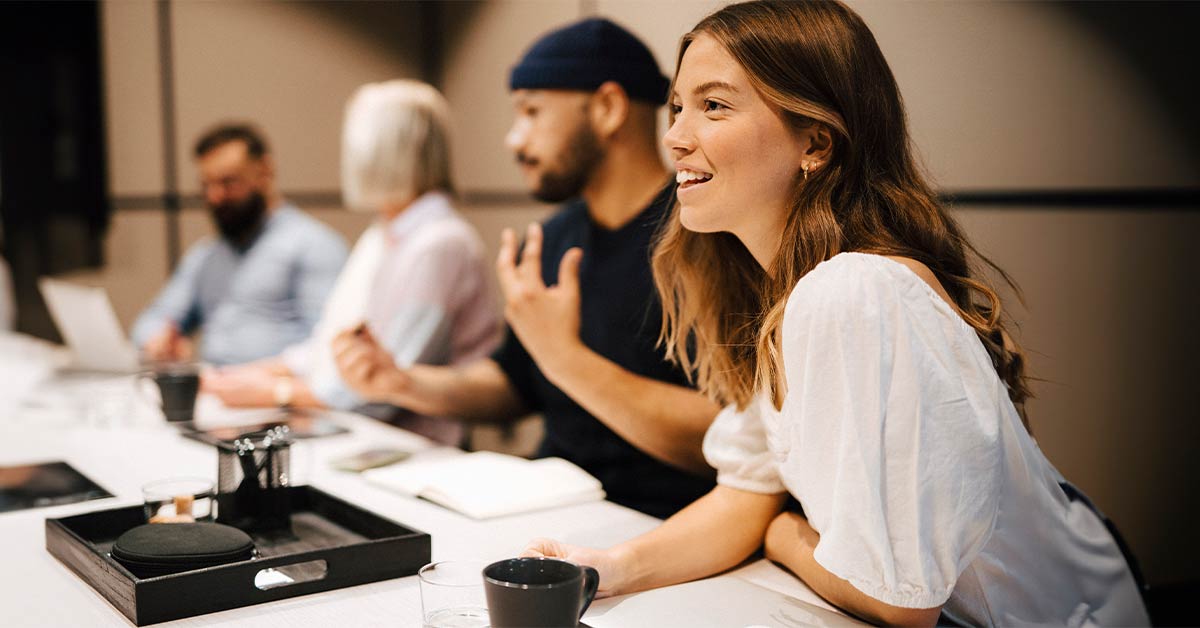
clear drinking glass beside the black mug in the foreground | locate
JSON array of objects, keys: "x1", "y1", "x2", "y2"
[{"x1": 416, "y1": 561, "x2": 488, "y2": 628}]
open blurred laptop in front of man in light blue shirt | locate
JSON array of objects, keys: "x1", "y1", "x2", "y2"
[{"x1": 37, "y1": 277, "x2": 138, "y2": 373}]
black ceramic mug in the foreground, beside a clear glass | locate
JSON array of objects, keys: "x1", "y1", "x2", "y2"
[{"x1": 484, "y1": 558, "x2": 600, "y2": 628}]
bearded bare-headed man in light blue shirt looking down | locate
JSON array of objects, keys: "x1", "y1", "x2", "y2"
[{"x1": 132, "y1": 124, "x2": 347, "y2": 365}]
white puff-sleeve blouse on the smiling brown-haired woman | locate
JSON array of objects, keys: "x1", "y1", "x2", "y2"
[{"x1": 704, "y1": 253, "x2": 1148, "y2": 626}]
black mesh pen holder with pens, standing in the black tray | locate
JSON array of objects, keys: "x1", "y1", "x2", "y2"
[{"x1": 217, "y1": 425, "x2": 292, "y2": 532}]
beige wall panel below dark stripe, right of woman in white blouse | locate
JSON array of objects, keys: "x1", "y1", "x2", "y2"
[{"x1": 959, "y1": 208, "x2": 1200, "y2": 582}]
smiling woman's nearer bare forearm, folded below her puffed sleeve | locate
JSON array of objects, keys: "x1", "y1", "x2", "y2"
[{"x1": 764, "y1": 513, "x2": 942, "y2": 626}]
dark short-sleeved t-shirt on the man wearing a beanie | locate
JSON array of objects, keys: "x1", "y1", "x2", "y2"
[{"x1": 492, "y1": 185, "x2": 713, "y2": 518}]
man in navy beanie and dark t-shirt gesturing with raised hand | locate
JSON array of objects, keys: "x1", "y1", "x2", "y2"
[{"x1": 338, "y1": 19, "x2": 719, "y2": 518}]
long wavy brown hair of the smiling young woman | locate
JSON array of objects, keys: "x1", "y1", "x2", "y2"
[{"x1": 653, "y1": 1, "x2": 1031, "y2": 425}]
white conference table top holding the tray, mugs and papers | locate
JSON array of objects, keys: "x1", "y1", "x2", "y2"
[{"x1": 0, "y1": 377, "x2": 859, "y2": 628}]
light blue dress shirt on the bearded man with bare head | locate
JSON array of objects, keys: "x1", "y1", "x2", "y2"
[{"x1": 132, "y1": 204, "x2": 346, "y2": 365}]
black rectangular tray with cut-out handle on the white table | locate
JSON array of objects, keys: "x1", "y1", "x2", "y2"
[{"x1": 46, "y1": 486, "x2": 431, "y2": 626}]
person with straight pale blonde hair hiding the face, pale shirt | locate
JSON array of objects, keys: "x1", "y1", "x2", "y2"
[{"x1": 204, "y1": 80, "x2": 500, "y2": 444}]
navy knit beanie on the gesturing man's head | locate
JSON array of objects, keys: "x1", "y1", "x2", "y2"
[{"x1": 509, "y1": 18, "x2": 670, "y2": 104}]
